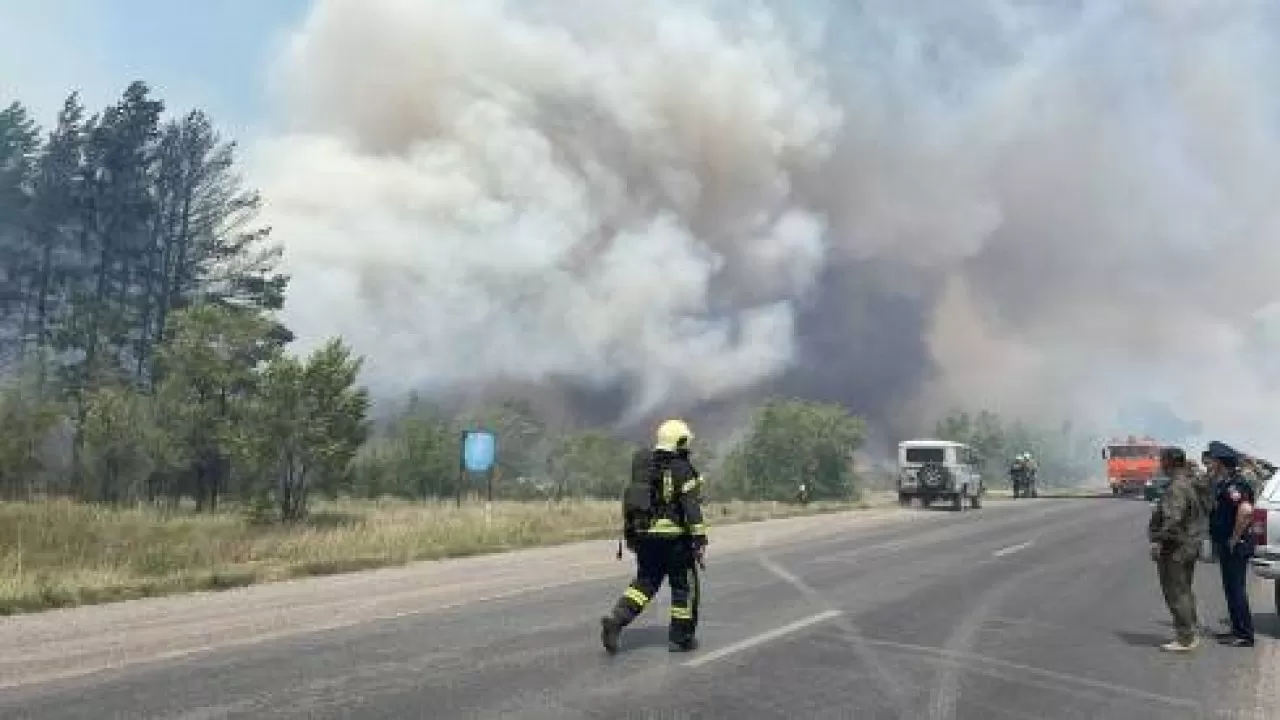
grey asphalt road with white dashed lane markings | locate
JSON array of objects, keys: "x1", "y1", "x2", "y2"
[{"x1": 0, "y1": 498, "x2": 1280, "y2": 720}]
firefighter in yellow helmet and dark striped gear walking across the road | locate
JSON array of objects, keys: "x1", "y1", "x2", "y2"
[{"x1": 600, "y1": 420, "x2": 707, "y2": 653}]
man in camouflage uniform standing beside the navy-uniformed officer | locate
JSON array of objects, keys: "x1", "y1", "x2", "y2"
[{"x1": 1147, "y1": 447, "x2": 1212, "y2": 652}]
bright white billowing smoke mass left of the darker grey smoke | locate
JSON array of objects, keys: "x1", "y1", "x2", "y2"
[{"x1": 254, "y1": 1, "x2": 840, "y2": 420}]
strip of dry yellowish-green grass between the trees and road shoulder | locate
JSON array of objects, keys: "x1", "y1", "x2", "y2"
[{"x1": 0, "y1": 501, "x2": 874, "y2": 615}]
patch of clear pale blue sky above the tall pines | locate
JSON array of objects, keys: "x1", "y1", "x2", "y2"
[{"x1": 0, "y1": 0, "x2": 310, "y2": 136}]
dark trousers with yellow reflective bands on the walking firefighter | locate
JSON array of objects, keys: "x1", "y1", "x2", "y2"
[{"x1": 613, "y1": 536, "x2": 700, "y2": 644}]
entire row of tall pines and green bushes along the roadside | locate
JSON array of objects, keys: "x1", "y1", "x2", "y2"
[{"x1": 0, "y1": 82, "x2": 1090, "y2": 519}]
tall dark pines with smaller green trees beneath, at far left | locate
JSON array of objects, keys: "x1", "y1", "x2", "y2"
[{"x1": 0, "y1": 82, "x2": 369, "y2": 518}]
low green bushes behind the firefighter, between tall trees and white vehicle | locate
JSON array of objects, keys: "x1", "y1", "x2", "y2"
[{"x1": 355, "y1": 398, "x2": 864, "y2": 500}]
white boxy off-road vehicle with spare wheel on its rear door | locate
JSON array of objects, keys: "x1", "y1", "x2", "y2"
[{"x1": 897, "y1": 439, "x2": 984, "y2": 510}]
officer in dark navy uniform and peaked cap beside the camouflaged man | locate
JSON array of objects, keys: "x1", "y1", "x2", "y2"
[{"x1": 1207, "y1": 441, "x2": 1253, "y2": 647}]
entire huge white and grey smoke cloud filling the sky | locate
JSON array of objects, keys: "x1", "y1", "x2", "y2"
[{"x1": 255, "y1": 0, "x2": 1280, "y2": 450}]
